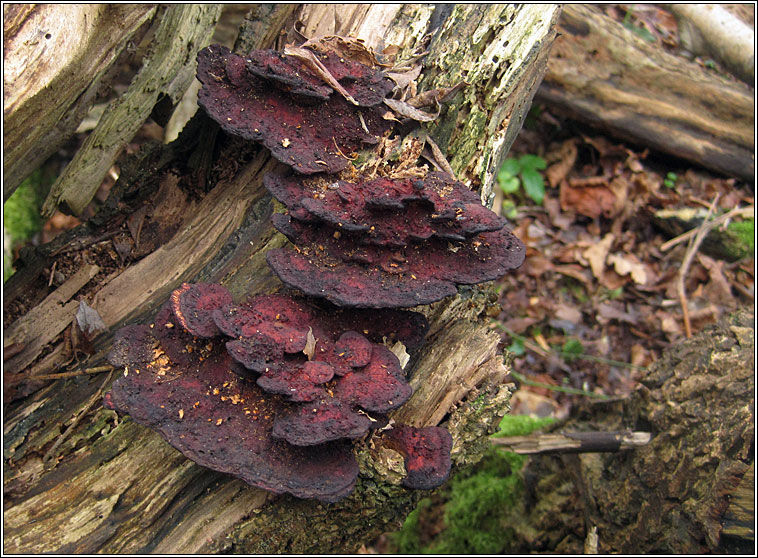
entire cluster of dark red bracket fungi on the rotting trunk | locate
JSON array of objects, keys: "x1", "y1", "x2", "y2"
[{"x1": 106, "y1": 39, "x2": 524, "y2": 502}]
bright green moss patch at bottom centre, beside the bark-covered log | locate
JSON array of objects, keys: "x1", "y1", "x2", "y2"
[{"x1": 390, "y1": 415, "x2": 554, "y2": 554}]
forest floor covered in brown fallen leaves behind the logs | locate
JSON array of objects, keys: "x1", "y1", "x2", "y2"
[{"x1": 4, "y1": 5, "x2": 755, "y2": 554}]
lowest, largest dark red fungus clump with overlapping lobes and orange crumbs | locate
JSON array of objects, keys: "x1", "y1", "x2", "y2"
[{"x1": 105, "y1": 284, "x2": 450, "y2": 502}]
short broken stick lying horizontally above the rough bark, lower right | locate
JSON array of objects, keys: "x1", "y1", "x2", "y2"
[{"x1": 490, "y1": 430, "x2": 651, "y2": 455}]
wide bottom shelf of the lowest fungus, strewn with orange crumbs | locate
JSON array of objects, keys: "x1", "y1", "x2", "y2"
[{"x1": 105, "y1": 306, "x2": 358, "y2": 502}]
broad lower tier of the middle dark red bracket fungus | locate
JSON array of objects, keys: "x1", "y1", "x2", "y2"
[{"x1": 266, "y1": 213, "x2": 525, "y2": 308}]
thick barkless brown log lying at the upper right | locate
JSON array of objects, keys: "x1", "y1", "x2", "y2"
[{"x1": 537, "y1": 4, "x2": 755, "y2": 181}]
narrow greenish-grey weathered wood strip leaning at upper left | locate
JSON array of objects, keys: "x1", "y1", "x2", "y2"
[{"x1": 42, "y1": 4, "x2": 221, "y2": 216}]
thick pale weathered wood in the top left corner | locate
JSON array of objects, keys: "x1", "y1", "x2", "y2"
[{"x1": 3, "y1": 4, "x2": 155, "y2": 200}]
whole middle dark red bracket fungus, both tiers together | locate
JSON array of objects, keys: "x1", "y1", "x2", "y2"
[{"x1": 265, "y1": 173, "x2": 526, "y2": 308}]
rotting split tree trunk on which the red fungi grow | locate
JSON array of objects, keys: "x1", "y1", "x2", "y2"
[{"x1": 4, "y1": 4, "x2": 560, "y2": 553}]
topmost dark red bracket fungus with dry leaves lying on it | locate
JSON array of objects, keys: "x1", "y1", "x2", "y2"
[{"x1": 197, "y1": 45, "x2": 392, "y2": 174}]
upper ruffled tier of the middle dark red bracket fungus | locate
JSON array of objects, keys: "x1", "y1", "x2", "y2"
[{"x1": 264, "y1": 172, "x2": 505, "y2": 246}]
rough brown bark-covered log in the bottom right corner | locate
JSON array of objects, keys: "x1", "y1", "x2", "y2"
[{"x1": 505, "y1": 309, "x2": 755, "y2": 555}]
